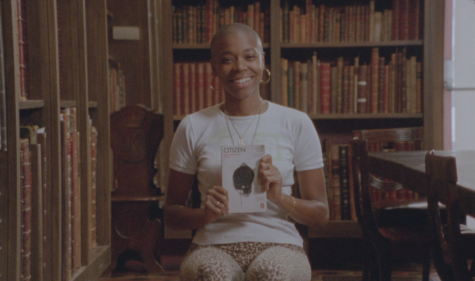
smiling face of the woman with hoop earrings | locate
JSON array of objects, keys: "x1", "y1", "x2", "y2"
[{"x1": 211, "y1": 31, "x2": 264, "y2": 99}]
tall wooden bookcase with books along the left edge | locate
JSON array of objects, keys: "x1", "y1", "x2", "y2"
[{"x1": 0, "y1": 0, "x2": 112, "y2": 281}]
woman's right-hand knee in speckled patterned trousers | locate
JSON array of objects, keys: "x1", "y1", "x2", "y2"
[{"x1": 246, "y1": 247, "x2": 311, "y2": 281}]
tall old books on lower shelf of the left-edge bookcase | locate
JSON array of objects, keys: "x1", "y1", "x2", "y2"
[{"x1": 20, "y1": 108, "x2": 97, "y2": 280}]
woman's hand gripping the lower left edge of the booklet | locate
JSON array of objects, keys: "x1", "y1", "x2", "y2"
[{"x1": 205, "y1": 186, "x2": 229, "y2": 223}]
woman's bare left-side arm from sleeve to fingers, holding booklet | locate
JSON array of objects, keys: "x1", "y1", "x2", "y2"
[{"x1": 163, "y1": 169, "x2": 229, "y2": 230}]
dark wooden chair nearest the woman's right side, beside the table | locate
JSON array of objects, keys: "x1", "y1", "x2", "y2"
[{"x1": 348, "y1": 139, "x2": 430, "y2": 281}]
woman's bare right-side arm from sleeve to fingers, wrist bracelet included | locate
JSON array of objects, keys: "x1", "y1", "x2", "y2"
[{"x1": 259, "y1": 155, "x2": 329, "y2": 226}]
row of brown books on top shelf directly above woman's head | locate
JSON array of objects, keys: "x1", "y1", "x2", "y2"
[{"x1": 172, "y1": 0, "x2": 270, "y2": 44}]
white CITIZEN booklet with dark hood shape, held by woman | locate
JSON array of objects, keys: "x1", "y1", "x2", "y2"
[{"x1": 221, "y1": 145, "x2": 267, "y2": 213}]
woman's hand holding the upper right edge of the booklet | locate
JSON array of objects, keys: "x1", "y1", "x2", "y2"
[{"x1": 258, "y1": 154, "x2": 282, "y2": 205}]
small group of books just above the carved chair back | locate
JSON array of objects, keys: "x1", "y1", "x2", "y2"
[{"x1": 109, "y1": 59, "x2": 125, "y2": 113}]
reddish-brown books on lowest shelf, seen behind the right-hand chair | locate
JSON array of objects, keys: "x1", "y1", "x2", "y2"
[{"x1": 322, "y1": 138, "x2": 421, "y2": 221}]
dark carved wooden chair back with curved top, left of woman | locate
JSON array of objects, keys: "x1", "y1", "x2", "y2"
[{"x1": 110, "y1": 104, "x2": 163, "y2": 198}]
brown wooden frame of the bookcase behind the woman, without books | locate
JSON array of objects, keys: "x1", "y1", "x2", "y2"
[{"x1": 161, "y1": 0, "x2": 444, "y2": 237}]
